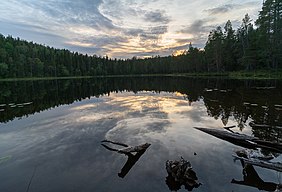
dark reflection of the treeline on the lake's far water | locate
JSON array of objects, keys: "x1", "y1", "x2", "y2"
[{"x1": 0, "y1": 77, "x2": 282, "y2": 145}]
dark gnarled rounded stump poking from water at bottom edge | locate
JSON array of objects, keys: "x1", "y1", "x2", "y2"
[{"x1": 166, "y1": 157, "x2": 201, "y2": 191}]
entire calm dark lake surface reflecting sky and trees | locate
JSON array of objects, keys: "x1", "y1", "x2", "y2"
[{"x1": 0, "y1": 77, "x2": 282, "y2": 192}]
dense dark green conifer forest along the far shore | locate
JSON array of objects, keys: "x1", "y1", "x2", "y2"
[{"x1": 0, "y1": 0, "x2": 282, "y2": 78}]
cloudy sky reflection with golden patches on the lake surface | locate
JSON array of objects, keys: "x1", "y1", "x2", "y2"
[{"x1": 0, "y1": 91, "x2": 278, "y2": 192}]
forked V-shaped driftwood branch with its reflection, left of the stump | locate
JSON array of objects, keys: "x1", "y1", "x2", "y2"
[{"x1": 101, "y1": 140, "x2": 151, "y2": 178}]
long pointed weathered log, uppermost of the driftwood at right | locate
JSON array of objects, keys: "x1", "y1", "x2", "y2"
[{"x1": 195, "y1": 127, "x2": 282, "y2": 153}]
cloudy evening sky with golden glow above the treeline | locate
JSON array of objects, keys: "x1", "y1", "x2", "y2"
[{"x1": 0, "y1": 0, "x2": 263, "y2": 58}]
